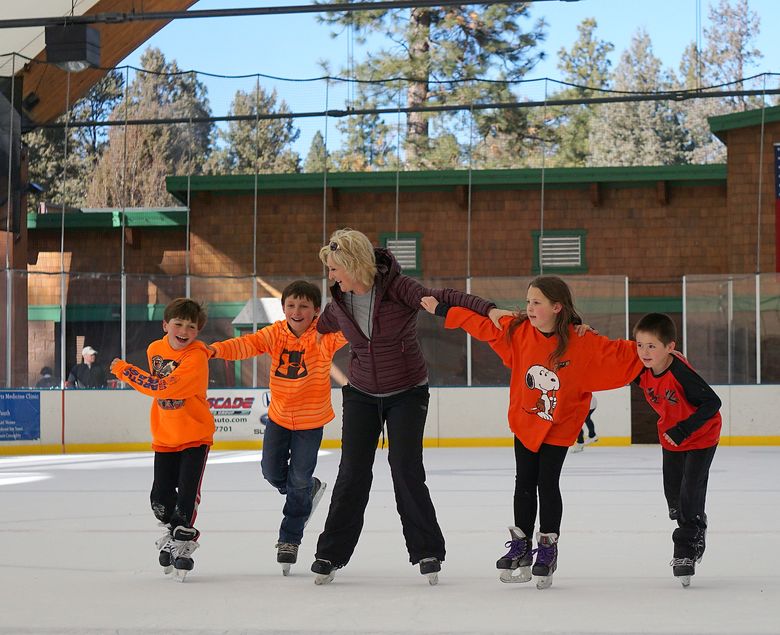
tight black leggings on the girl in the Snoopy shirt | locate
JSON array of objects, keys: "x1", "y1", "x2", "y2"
[{"x1": 514, "y1": 437, "x2": 569, "y2": 538}]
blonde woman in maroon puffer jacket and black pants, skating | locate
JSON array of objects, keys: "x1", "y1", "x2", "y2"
[{"x1": 312, "y1": 229, "x2": 495, "y2": 584}]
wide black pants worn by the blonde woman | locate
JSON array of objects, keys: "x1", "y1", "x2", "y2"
[{"x1": 316, "y1": 386, "x2": 444, "y2": 566}]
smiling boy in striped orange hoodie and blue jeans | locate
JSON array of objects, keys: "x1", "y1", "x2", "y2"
[{"x1": 211, "y1": 280, "x2": 346, "y2": 575}]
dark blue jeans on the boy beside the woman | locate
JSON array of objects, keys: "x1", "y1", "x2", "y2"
[{"x1": 260, "y1": 419, "x2": 322, "y2": 545}]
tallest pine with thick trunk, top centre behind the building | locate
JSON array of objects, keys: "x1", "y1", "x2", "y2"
[{"x1": 323, "y1": 0, "x2": 545, "y2": 168}]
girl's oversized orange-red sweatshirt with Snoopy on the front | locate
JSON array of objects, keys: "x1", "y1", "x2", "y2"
[{"x1": 445, "y1": 307, "x2": 643, "y2": 452}]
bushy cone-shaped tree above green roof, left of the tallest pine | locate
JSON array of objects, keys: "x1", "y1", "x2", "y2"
[{"x1": 207, "y1": 86, "x2": 300, "y2": 174}]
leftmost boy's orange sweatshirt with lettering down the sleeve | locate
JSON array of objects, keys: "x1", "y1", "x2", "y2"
[{"x1": 113, "y1": 336, "x2": 214, "y2": 452}]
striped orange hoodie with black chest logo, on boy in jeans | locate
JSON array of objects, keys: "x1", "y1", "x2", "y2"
[{"x1": 211, "y1": 319, "x2": 347, "y2": 430}]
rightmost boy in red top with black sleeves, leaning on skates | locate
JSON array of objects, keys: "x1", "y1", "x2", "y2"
[{"x1": 634, "y1": 313, "x2": 721, "y2": 586}]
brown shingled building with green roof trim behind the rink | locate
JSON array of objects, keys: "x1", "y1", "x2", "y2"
[{"x1": 6, "y1": 107, "x2": 780, "y2": 392}]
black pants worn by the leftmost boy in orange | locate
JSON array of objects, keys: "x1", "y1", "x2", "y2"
[{"x1": 150, "y1": 445, "x2": 209, "y2": 528}]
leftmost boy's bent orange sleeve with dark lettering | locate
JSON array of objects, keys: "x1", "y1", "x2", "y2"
[{"x1": 112, "y1": 349, "x2": 208, "y2": 399}]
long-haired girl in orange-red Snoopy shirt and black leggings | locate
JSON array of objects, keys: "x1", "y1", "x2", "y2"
[{"x1": 423, "y1": 276, "x2": 642, "y2": 589}]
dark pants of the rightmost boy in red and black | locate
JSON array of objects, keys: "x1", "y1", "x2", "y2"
[{"x1": 661, "y1": 445, "x2": 718, "y2": 528}]
